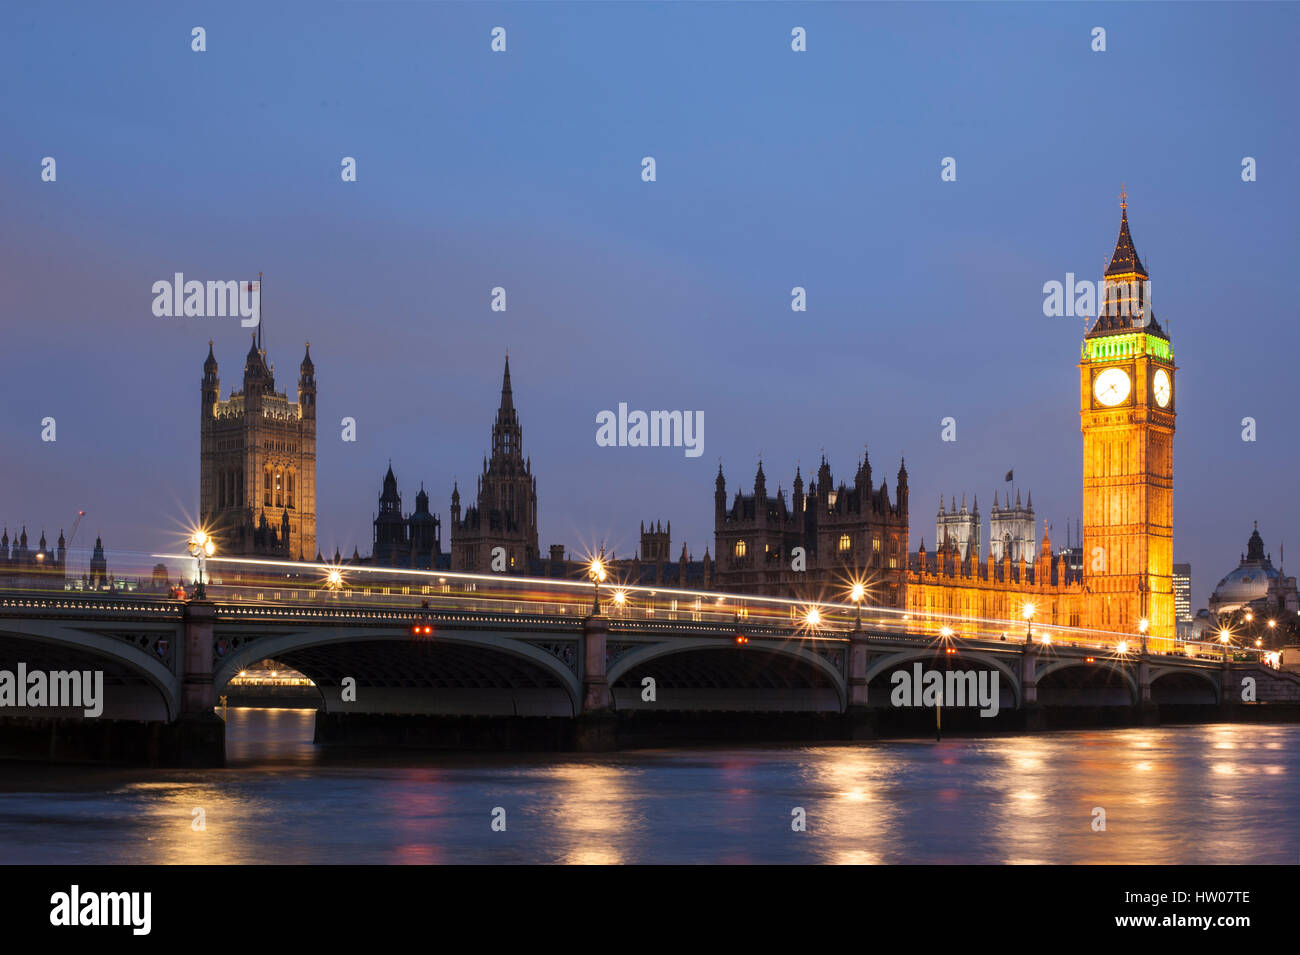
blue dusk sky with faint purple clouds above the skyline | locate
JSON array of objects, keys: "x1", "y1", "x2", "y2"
[{"x1": 0, "y1": 3, "x2": 1300, "y2": 607}]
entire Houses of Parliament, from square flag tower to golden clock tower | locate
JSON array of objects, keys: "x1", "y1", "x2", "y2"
[{"x1": 200, "y1": 197, "x2": 1177, "y2": 641}]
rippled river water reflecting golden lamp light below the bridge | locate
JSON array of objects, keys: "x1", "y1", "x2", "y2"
[{"x1": 0, "y1": 709, "x2": 1300, "y2": 864}]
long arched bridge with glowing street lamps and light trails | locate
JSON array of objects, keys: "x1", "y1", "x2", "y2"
[{"x1": 0, "y1": 559, "x2": 1300, "y2": 761}]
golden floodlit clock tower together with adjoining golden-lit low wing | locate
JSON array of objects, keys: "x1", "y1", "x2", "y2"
[{"x1": 906, "y1": 197, "x2": 1175, "y2": 642}]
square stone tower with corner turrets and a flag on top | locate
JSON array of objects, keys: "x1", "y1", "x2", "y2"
[{"x1": 199, "y1": 335, "x2": 316, "y2": 560}]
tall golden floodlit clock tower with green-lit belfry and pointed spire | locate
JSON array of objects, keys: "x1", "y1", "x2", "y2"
[{"x1": 1079, "y1": 195, "x2": 1177, "y2": 646}]
